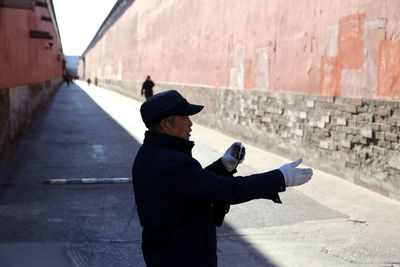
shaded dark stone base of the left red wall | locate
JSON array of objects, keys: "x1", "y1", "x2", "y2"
[{"x1": 0, "y1": 78, "x2": 63, "y2": 166}]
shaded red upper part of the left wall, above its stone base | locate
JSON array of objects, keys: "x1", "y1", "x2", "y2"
[{"x1": 0, "y1": 5, "x2": 63, "y2": 88}]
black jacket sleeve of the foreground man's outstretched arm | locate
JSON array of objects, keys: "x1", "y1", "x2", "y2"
[{"x1": 171, "y1": 158, "x2": 286, "y2": 205}]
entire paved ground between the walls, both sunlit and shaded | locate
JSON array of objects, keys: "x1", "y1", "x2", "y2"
[{"x1": 0, "y1": 82, "x2": 400, "y2": 266}]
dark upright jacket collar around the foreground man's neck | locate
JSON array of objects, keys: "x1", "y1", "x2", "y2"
[{"x1": 143, "y1": 131, "x2": 194, "y2": 156}]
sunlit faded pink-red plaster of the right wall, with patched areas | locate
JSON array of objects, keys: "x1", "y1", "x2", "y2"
[{"x1": 79, "y1": 0, "x2": 400, "y2": 99}]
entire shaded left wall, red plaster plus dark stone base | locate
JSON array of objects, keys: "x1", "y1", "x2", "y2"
[{"x1": 0, "y1": 3, "x2": 63, "y2": 166}]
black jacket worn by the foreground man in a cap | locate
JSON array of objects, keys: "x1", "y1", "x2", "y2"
[{"x1": 132, "y1": 132, "x2": 285, "y2": 267}]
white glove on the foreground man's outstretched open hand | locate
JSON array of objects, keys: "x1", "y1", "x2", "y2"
[{"x1": 279, "y1": 159, "x2": 313, "y2": 187}]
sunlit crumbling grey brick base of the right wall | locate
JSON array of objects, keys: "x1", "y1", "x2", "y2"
[{"x1": 100, "y1": 80, "x2": 400, "y2": 200}]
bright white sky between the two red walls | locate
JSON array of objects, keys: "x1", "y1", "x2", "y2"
[{"x1": 53, "y1": 0, "x2": 117, "y2": 56}]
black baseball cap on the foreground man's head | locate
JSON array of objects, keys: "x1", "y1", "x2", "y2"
[{"x1": 140, "y1": 90, "x2": 204, "y2": 128}]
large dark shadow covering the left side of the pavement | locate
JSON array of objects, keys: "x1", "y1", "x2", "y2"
[{"x1": 0, "y1": 84, "x2": 280, "y2": 266}]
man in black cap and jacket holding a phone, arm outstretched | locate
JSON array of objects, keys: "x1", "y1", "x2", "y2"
[{"x1": 132, "y1": 90, "x2": 312, "y2": 267}]
